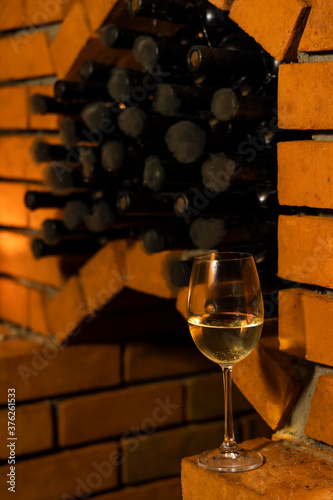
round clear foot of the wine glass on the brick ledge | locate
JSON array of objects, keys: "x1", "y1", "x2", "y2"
[{"x1": 198, "y1": 448, "x2": 264, "y2": 472}]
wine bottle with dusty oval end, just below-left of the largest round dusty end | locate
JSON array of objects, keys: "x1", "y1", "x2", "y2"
[{"x1": 143, "y1": 155, "x2": 201, "y2": 191}]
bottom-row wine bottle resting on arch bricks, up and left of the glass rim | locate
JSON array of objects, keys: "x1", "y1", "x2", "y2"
[{"x1": 142, "y1": 225, "x2": 192, "y2": 253}]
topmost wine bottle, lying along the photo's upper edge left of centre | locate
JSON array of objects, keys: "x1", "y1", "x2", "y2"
[{"x1": 127, "y1": 0, "x2": 200, "y2": 24}]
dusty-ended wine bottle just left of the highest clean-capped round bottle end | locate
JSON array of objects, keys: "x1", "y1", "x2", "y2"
[{"x1": 133, "y1": 35, "x2": 190, "y2": 73}]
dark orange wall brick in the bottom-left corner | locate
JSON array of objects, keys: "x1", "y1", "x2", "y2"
[{"x1": 0, "y1": 442, "x2": 119, "y2": 500}]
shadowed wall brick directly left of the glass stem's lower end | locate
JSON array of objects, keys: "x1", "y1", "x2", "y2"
[{"x1": 121, "y1": 422, "x2": 223, "y2": 486}]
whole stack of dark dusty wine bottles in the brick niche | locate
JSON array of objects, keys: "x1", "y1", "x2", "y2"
[{"x1": 26, "y1": 0, "x2": 286, "y2": 286}]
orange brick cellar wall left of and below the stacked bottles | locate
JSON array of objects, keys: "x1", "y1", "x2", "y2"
[{"x1": 0, "y1": 0, "x2": 272, "y2": 500}]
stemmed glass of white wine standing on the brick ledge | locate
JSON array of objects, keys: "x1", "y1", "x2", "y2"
[{"x1": 187, "y1": 252, "x2": 264, "y2": 472}]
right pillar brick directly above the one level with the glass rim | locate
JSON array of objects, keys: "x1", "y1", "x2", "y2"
[{"x1": 278, "y1": 141, "x2": 333, "y2": 209}]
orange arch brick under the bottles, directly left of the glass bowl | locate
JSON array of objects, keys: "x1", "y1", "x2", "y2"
[{"x1": 126, "y1": 241, "x2": 183, "y2": 298}]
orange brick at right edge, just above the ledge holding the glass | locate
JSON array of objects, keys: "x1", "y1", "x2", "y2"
[{"x1": 305, "y1": 374, "x2": 333, "y2": 446}]
